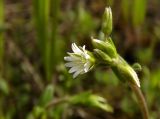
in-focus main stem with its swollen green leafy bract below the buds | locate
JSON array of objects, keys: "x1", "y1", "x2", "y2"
[{"x1": 112, "y1": 56, "x2": 149, "y2": 119}]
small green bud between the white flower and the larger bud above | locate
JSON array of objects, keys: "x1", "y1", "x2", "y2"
[{"x1": 94, "y1": 49, "x2": 112, "y2": 64}]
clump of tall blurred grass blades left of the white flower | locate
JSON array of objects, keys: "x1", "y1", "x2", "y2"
[{"x1": 33, "y1": 0, "x2": 60, "y2": 80}]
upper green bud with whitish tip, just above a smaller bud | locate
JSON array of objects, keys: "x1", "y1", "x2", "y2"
[{"x1": 92, "y1": 39, "x2": 117, "y2": 58}]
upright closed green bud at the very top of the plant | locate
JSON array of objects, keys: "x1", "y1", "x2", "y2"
[{"x1": 102, "y1": 7, "x2": 112, "y2": 36}]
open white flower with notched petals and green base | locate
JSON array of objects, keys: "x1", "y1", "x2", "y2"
[{"x1": 64, "y1": 43, "x2": 94, "y2": 78}]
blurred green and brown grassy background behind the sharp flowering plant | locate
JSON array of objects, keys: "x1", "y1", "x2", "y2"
[{"x1": 0, "y1": 0, "x2": 160, "y2": 119}]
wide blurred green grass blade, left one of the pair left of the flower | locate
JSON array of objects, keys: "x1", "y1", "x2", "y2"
[{"x1": 33, "y1": 0, "x2": 51, "y2": 79}]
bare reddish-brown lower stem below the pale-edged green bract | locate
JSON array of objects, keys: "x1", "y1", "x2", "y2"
[{"x1": 129, "y1": 83, "x2": 149, "y2": 119}]
